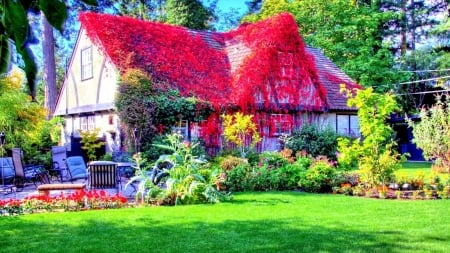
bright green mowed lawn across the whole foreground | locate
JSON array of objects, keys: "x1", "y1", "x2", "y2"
[{"x1": 0, "y1": 192, "x2": 450, "y2": 253}]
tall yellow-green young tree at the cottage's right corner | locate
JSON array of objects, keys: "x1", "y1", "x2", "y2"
[{"x1": 338, "y1": 88, "x2": 403, "y2": 188}]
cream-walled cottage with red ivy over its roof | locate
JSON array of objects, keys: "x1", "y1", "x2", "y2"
[{"x1": 54, "y1": 13, "x2": 360, "y2": 156}]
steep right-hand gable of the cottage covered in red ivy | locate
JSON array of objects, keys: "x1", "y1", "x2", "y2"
[{"x1": 225, "y1": 13, "x2": 326, "y2": 111}]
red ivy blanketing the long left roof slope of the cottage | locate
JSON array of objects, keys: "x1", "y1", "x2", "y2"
[{"x1": 80, "y1": 13, "x2": 230, "y2": 104}]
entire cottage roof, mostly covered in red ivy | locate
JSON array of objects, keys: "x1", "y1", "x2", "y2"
[{"x1": 80, "y1": 10, "x2": 356, "y2": 111}]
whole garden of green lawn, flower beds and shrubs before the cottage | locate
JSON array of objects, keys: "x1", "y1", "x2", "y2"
[{"x1": 0, "y1": 50, "x2": 450, "y2": 252}]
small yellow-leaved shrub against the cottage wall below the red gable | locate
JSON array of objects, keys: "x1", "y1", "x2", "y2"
[{"x1": 222, "y1": 112, "x2": 261, "y2": 158}]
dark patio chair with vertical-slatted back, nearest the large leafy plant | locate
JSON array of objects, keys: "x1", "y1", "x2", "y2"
[{"x1": 88, "y1": 161, "x2": 120, "y2": 192}]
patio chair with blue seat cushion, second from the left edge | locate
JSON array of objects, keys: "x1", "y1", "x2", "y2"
[{"x1": 12, "y1": 148, "x2": 49, "y2": 191}]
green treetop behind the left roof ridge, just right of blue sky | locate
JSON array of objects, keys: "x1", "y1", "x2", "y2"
[{"x1": 166, "y1": 0, "x2": 215, "y2": 30}]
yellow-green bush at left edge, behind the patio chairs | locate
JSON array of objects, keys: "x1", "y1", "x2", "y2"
[{"x1": 0, "y1": 69, "x2": 57, "y2": 167}]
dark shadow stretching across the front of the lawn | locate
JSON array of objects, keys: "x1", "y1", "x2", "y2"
[{"x1": 0, "y1": 211, "x2": 430, "y2": 253}]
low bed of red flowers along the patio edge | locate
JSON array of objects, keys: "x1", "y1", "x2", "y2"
[{"x1": 0, "y1": 190, "x2": 127, "y2": 215}]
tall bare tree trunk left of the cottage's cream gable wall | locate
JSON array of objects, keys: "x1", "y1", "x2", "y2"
[{"x1": 41, "y1": 13, "x2": 57, "y2": 119}]
